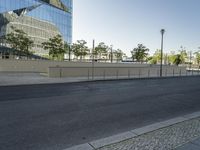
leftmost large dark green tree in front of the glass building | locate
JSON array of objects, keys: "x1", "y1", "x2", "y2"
[{"x1": 6, "y1": 26, "x2": 33, "y2": 56}]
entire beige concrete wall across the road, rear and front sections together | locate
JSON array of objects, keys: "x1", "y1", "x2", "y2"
[{"x1": 0, "y1": 59, "x2": 186, "y2": 77}]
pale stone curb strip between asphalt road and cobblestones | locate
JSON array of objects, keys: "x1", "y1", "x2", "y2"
[{"x1": 64, "y1": 111, "x2": 200, "y2": 150}]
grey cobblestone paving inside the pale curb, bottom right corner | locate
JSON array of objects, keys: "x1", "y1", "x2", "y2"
[{"x1": 98, "y1": 118, "x2": 200, "y2": 150}]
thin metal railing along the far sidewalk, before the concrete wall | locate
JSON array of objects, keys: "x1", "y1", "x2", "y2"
[{"x1": 49, "y1": 66, "x2": 200, "y2": 80}]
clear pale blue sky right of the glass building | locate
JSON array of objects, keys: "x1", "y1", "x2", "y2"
[{"x1": 73, "y1": 0, "x2": 200, "y2": 56}]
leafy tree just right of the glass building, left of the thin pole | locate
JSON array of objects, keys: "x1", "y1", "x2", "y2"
[{"x1": 72, "y1": 40, "x2": 89, "y2": 60}]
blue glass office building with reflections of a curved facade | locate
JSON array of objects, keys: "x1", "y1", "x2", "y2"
[{"x1": 0, "y1": 0, "x2": 72, "y2": 55}]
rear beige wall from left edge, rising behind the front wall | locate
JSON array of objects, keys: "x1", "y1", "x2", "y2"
[{"x1": 0, "y1": 59, "x2": 149, "y2": 73}]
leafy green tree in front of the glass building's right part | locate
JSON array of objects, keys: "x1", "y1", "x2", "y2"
[{"x1": 42, "y1": 34, "x2": 66, "y2": 60}]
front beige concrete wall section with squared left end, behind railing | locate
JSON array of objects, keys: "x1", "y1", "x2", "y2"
[{"x1": 49, "y1": 65, "x2": 186, "y2": 78}]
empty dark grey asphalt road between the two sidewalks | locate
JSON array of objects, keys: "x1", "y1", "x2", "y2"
[{"x1": 0, "y1": 77, "x2": 200, "y2": 150}]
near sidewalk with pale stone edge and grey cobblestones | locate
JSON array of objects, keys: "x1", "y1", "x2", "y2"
[{"x1": 65, "y1": 112, "x2": 200, "y2": 150}]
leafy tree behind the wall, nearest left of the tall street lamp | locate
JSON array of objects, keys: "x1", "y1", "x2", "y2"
[{"x1": 131, "y1": 44, "x2": 149, "y2": 63}]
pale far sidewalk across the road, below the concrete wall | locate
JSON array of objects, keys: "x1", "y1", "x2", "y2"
[{"x1": 0, "y1": 72, "x2": 198, "y2": 86}]
